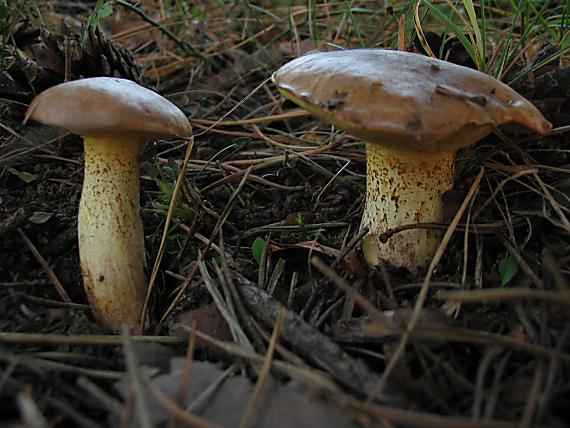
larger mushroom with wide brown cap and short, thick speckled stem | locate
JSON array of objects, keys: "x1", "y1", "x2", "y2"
[{"x1": 273, "y1": 49, "x2": 551, "y2": 274}]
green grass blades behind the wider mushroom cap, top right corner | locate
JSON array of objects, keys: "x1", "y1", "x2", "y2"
[{"x1": 407, "y1": 0, "x2": 570, "y2": 80}]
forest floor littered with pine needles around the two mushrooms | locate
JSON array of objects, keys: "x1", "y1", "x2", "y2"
[{"x1": 0, "y1": 0, "x2": 570, "y2": 427}]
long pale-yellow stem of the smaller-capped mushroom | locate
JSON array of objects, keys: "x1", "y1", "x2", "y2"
[{"x1": 78, "y1": 137, "x2": 147, "y2": 332}]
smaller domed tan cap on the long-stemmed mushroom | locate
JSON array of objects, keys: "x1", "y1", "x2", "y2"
[{"x1": 26, "y1": 77, "x2": 192, "y2": 140}]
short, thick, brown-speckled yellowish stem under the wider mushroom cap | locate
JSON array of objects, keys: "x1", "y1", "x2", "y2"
[{"x1": 361, "y1": 143, "x2": 455, "y2": 274}]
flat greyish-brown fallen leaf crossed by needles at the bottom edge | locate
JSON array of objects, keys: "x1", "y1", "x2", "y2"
[{"x1": 115, "y1": 357, "x2": 354, "y2": 428}]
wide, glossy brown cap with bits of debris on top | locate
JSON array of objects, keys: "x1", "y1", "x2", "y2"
[{"x1": 273, "y1": 49, "x2": 551, "y2": 152}]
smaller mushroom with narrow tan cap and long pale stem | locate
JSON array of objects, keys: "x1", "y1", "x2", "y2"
[{"x1": 25, "y1": 77, "x2": 192, "y2": 332}]
